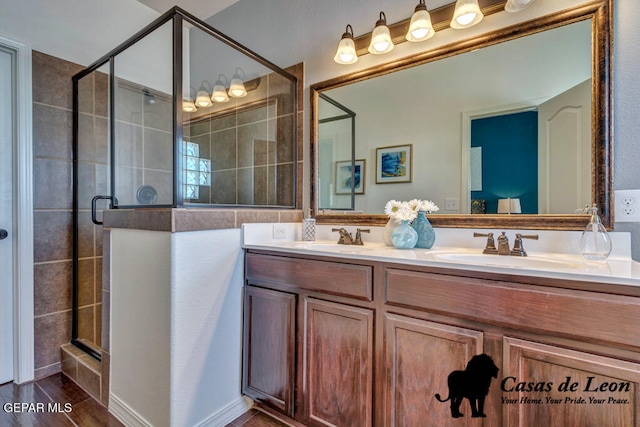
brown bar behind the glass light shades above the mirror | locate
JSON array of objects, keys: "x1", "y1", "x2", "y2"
[{"x1": 354, "y1": 0, "x2": 507, "y2": 56}]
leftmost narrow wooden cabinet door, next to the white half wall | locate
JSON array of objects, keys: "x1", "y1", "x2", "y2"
[{"x1": 242, "y1": 286, "x2": 296, "y2": 416}]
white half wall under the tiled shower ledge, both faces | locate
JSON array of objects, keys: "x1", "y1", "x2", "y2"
[{"x1": 109, "y1": 229, "x2": 251, "y2": 427}]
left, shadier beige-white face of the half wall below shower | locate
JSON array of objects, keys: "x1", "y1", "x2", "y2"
[{"x1": 109, "y1": 229, "x2": 171, "y2": 427}]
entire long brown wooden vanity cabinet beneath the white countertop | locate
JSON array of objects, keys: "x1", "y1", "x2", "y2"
[{"x1": 244, "y1": 251, "x2": 640, "y2": 427}]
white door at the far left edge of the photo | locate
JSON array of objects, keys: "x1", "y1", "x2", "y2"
[{"x1": 0, "y1": 46, "x2": 15, "y2": 384}]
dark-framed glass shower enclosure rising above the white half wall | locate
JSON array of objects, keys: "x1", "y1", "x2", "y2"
[{"x1": 72, "y1": 7, "x2": 297, "y2": 358}]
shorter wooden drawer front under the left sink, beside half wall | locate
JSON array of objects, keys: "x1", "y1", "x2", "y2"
[{"x1": 246, "y1": 253, "x2": 373, "y2": 301}]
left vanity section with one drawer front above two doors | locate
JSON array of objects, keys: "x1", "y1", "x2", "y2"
[{"x1": 243, "y1": 252, "x2": 374, "y2": 427}]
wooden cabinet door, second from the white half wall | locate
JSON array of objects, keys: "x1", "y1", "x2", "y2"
[{"x1": 304, "y1": 298, "x2": 373, "y2": 427}]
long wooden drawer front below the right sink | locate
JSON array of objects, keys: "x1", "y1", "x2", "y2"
[{"x1": 385, "y1": 268, "x2": 640, "y2": 347}]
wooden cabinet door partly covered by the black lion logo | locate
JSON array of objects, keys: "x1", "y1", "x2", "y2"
[{"x1": 381, "y1": 314, "x2": 488, "y2": 427}]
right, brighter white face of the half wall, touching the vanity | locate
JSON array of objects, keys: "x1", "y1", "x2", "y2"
[{"x1": 171, "y1": 229, "x2": 249, "y2": 426}]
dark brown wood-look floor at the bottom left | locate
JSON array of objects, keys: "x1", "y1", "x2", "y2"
[{"x1": 0, "y1": 374, "x2": 287, "y2": 427}]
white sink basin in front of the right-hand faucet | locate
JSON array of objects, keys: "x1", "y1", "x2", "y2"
[{"x1": 433, "y1": 253, "x2": 591, "y2": 270}]
